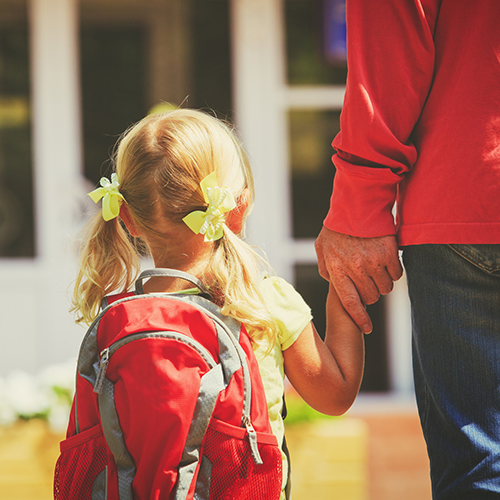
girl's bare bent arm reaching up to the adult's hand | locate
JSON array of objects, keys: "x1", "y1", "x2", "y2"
[{"x1": 283, "y1": 285, "x2": 364, "y2": 415}]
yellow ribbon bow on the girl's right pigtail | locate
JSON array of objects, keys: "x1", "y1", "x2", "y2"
[{"x1": 182, "y1": 172, "x2": 236, "y2": 241}]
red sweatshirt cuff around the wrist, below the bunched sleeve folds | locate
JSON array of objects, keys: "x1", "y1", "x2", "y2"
[{"x1": 323, "y1": 155, "x2": 400, "y2": 238}]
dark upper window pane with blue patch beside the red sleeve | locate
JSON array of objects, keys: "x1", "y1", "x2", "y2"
[{"x1": 284, "y1": 0, "x2": 347, "y2": 85}]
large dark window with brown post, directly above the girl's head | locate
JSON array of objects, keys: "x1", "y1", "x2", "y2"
[{"x1": 80, "y1": 0, "x2": 231, "y2": 183}]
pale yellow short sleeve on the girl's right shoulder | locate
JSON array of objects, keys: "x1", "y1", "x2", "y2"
[{"x1": 259, "y1": 276, "x2": 312, "y2": 350}]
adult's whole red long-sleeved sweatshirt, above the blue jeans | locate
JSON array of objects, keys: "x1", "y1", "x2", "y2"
[{"x1": 324, "y1": 0, "x2": 500, "y2": 246}]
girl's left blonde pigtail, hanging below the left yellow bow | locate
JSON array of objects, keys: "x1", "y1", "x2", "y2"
[{"x1": 71, "y1": 212, "x2": 140, "y2": 324}]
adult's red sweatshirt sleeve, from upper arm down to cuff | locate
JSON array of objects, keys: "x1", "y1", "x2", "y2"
[{"x1": 324, "y1": 0, "x2": 440, "y2": 237}]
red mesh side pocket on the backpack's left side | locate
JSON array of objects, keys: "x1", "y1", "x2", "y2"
[{"x1": 54, "y1": 425, "x2": 107, "y2": 500}]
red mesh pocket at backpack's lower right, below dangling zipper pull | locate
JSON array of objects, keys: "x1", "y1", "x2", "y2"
[{"x1": 203, "y1": 420, "x2": 283, "y2": 500}]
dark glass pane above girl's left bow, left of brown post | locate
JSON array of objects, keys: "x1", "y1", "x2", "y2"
[{"x1": 80, "y1": 24, "x2": 148, "y2": 183}]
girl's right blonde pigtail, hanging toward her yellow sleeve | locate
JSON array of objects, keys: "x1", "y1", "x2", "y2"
[{"x1": 210, "y1": 227, "x2": 278, "y2": 348}]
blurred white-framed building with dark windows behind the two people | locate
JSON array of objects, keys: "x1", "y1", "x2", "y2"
[{"x1": 0, "y1": 0, "x2": 413, "y2": 405}]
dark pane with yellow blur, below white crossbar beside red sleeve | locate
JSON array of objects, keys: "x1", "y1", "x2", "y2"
[{"x1": 288, "y1": 110, "x2": 340, "y2": 238}]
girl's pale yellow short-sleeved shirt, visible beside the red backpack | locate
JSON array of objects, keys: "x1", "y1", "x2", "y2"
[{"x1": 253, "y1": 277, "x2": 312, "y2": 500}]
